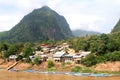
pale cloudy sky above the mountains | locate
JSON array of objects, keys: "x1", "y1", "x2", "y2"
[{"x1": 0, "y1": 0, "x2": 120, "y2": 33}]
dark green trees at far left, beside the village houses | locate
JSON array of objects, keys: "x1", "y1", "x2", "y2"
[{"x1": 0, "y1": 42, "x2": 34, "y2": 60}]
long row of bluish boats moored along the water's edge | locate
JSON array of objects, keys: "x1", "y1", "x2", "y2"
[{"x1": 2, "y1": 69, "x2": 120, "y2": 77}]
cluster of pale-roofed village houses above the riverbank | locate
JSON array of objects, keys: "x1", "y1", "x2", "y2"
[{"x1": 9, "y1": 43, "x2": 91, "y2": 64}]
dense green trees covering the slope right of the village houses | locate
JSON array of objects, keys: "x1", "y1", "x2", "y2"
[{"x1": 68, "y1": 32, "x2": 120, "y2": 66}]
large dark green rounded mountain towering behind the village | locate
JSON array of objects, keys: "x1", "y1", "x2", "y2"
[{"x1": 0, "y1": 6, "x2": 72, "y2": 43}]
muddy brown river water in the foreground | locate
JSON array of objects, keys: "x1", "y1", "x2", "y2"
[{"x1": 0, "y1": 70, "x2": 120, "y2": 80}]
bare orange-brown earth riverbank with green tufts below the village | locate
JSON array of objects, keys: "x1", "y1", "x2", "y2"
[{"x1": 0, "y1": 59, "x2": 120, "y2": 74}]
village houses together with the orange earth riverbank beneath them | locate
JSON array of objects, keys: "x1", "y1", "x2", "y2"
[{"x1": 0, "y1": 42, "x2": 120, "y2": 72}]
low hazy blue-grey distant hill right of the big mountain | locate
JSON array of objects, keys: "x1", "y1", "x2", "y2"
[{"x1": 72, "y1": 30, "x2": 101, "y2": 37}]
